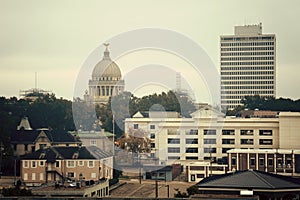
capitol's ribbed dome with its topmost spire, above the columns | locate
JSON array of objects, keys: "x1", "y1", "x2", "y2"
[{"x1": 92, "y1": 44, "x2": 122, "y2": 80}]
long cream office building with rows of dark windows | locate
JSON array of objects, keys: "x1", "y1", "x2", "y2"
[{"x1": 125, "y1": 106, "x2": 300, "y2": 164}]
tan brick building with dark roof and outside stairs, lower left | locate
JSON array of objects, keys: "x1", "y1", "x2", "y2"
[{"x1": 21, "y1": 147, "x2": 111, "y2": 186}]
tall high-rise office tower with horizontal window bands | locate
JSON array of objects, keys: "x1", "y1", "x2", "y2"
[{"x1": 220, "y1": 23, "x2": 276, "y2": 109}]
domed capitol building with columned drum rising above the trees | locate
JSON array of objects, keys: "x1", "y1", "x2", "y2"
[{"x1": 84, "y1": 43, "x2": 124, "y2": 105}]
